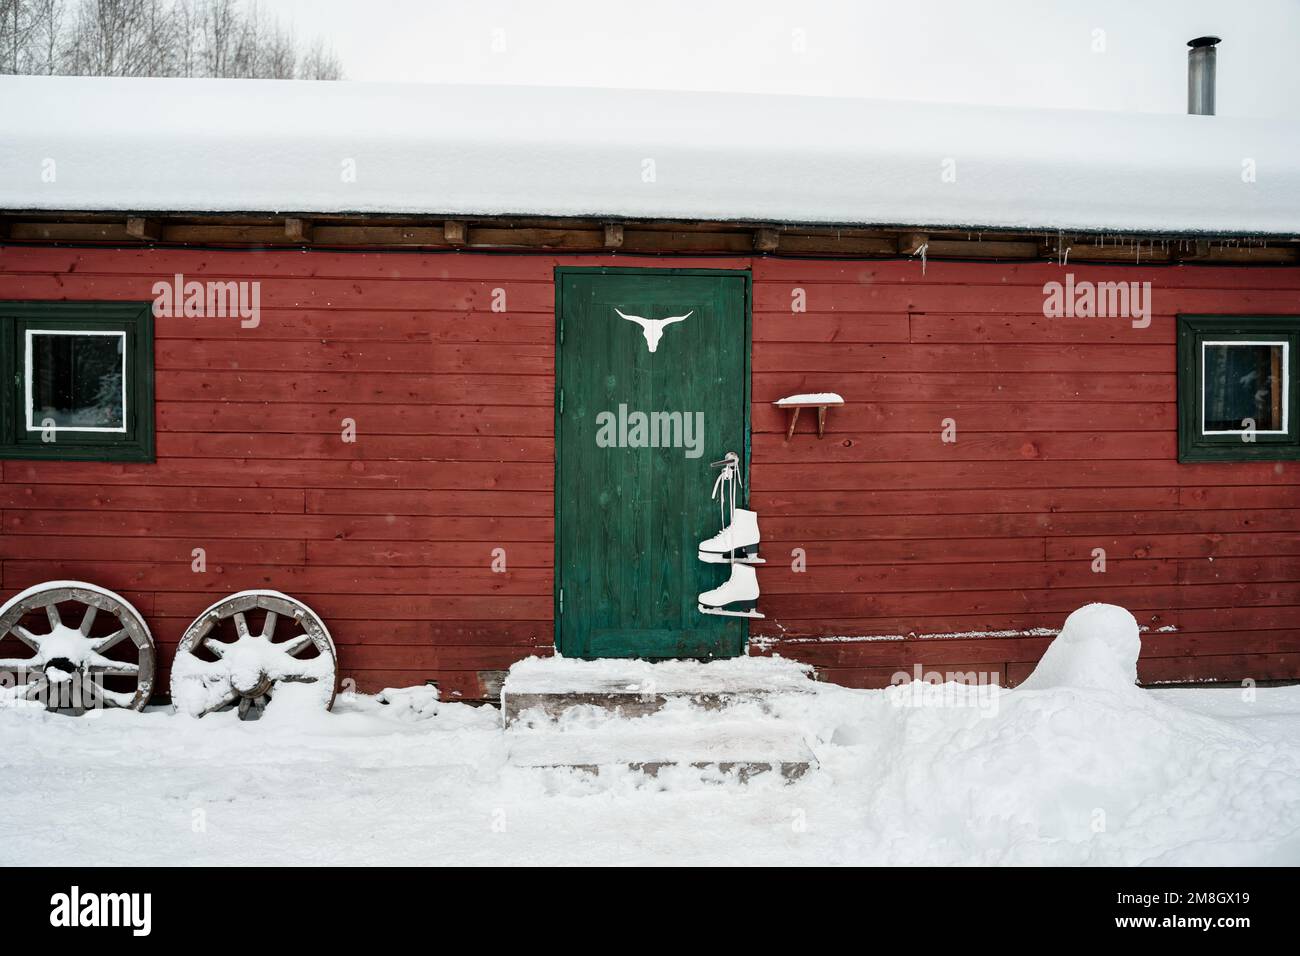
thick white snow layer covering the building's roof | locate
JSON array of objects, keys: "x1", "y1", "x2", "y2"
[{"x1": 0, "y1": 77, "x2": 1300, "y2": 235}]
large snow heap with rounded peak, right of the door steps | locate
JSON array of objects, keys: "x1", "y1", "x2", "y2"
[{"x1": 837, "y1": 604, "x2": 1300, "y2": 865}]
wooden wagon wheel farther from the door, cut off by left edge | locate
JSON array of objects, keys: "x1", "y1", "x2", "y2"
[{"x1": 0, "y1": 581, "x2": 155, "y2": 714}]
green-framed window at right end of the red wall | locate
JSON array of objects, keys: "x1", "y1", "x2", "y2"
[{"x1": 1178, "y1": 315, "x2": 1300, "y2": 462}]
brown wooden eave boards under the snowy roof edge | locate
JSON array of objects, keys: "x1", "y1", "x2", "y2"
[{"x1": 0, "y1": 209, "x2": 1300, "y2": 265}]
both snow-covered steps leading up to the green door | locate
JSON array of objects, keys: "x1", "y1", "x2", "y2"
[{"x1": 502, "y1": 658, "x2": 816, "y2": 782}]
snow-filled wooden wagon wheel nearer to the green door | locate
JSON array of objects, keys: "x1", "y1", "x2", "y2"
[{"x1": 172, "y1": 591, "x2": 338, "y2": 719}]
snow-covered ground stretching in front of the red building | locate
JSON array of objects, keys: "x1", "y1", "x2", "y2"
[{"x1": 0, "y1": 618, "x2": 1300, "y2": 865}]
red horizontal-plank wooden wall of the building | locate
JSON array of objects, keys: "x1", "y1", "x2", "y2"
[{"x1": 0, "y1": 246, "x2": 1300, "y2": 697}]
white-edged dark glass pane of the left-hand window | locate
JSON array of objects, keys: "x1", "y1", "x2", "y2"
[{"x1": 27, "y1": 330, "x2": 126, "y2": 429}]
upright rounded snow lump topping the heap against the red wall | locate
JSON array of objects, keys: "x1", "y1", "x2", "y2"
[{"x1": 1021, "y1": 604, "x2": 1141, "y2": 691}]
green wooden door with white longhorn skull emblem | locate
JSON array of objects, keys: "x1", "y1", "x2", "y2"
[{"x1": 555, "y1": 269, "x2": 749, "y2": 658}]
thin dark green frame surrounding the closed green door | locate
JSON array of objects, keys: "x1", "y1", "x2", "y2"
[{"x1": 551, "y1": 265, "x2": 754, "y2": 656}]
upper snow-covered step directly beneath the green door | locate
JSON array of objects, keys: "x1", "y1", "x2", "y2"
[{"x1": 501, "y1": 657, "x2": 815, "y2": 726}]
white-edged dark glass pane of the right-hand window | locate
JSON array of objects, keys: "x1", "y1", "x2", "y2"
[{"x1": 1205, "y1": 342, "x2": 1286, "y2": 432}]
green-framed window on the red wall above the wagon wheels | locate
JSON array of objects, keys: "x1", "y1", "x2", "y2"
[{"x1": 0, "y1": 302, "x2": 153, "y2": 462}]
